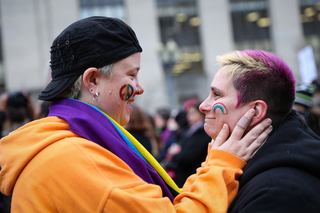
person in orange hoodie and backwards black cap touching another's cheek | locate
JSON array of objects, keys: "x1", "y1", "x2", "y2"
[{"x1": 0, "y1": 17, "x2": 271, "y2": 213}]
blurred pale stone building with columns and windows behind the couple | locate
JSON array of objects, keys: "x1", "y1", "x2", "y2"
[{"x1": 0, "y1": 0, "x2": 320, "y2": 112}]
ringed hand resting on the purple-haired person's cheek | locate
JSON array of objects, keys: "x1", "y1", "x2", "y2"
[{"x1": 211, "y1": 109, "x2": 272, "y2": 161}]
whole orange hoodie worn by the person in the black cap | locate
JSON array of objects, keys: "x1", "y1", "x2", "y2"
[{"x1": 0, "y1": 117, "x2": 245, "y2": 213}]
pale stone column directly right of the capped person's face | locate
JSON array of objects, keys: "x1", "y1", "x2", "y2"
[{"x1": 125, "y1": 0, "x2": 169, "y2": 113}]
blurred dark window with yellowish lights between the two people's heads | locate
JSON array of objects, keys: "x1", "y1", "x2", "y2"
[{"x1": 157, "y1": 0, "x2": 202, "y2": 76}]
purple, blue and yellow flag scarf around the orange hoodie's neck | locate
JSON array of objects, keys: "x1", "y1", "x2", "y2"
[{"x1": 48, "y1": 99, "x2": 180, "y2": 201}]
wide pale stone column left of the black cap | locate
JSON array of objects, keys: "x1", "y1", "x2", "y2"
[{"x1": 1, "y1": 0, "x2": 78, "y2": 92}]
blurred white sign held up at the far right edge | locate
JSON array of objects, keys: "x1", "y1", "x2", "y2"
[{"x1": 298, "y1": 45, "x2": 318, "y2": 85}]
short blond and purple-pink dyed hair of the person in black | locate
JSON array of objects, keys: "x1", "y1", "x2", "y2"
[{"x1": 217, "y1": 50, "x2": 295, "y2": 125}]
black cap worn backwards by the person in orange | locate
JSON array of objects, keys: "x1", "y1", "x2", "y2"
[{"x1": 38, "y1": 16, "x2": 142, "y2": 101}]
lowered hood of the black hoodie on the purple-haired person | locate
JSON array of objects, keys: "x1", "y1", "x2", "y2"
[{"x1": 240, "y1": 111, "x2": 320, "y2": 188}]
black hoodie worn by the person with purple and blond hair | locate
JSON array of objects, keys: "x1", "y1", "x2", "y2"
[{"x1": 228, "y1": 111, "x2": 320, "y2": 213}]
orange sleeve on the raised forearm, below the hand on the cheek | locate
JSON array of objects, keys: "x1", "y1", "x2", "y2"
[{"x1": 174, "y1": 145, "x2": 246, "y2": 212}]
